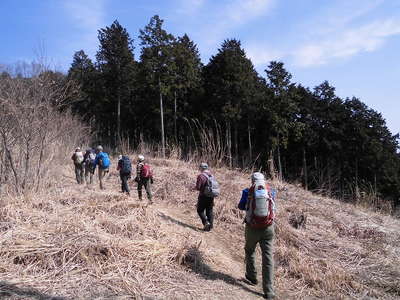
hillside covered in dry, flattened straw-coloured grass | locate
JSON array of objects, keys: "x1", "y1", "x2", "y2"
[{"x1": 0, "y1": 159, "x2": 400, "y2": 299}]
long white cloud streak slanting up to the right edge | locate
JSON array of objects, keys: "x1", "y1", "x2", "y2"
[{"x1": 292, "y1": 19, "x2": 400, "y2": 67}]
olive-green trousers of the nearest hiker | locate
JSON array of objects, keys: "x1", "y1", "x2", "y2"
[{"x1": 244, "y1": 224, "x2": 275, "y2": 298}]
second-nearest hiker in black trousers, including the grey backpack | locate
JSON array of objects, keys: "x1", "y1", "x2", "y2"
[{"x1": 195, "y1": 162, "x2": 219, "y2": 231}]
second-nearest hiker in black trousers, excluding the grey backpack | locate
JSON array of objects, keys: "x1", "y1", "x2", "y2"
[{"x1": 195, "y1": 162, "x2": 214, "y2": 231}]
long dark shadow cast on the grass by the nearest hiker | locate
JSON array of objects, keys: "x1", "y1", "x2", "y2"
[{"x1": 182, "y1": 247, "x2": 264, "y2": 297}]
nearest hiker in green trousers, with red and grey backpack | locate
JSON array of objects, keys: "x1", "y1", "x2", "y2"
[{"x1": 238, "y1": 172, "x2": 275, "y2": 299}]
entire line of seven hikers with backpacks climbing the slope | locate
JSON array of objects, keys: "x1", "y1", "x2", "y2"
[{"x1": 71, "y1": 145, "x2": 276, "y2": 299}]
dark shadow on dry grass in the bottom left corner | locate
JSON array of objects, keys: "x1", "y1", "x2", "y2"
[{"x1": 0, "y1": 281, "x2": 67, "y2": 300}]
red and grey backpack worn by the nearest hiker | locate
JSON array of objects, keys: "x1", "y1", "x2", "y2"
[{"x1": 249, "y1": 185, "x2": 275, "y2": 228}]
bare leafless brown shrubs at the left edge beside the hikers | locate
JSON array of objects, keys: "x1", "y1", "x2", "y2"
[{"x1": 0, "y1": 66, "x2": 87, "y2": 193}]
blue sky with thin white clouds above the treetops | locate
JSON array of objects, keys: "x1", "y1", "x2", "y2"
[{"x1": 0, "y1": 0, "x2": 400, "y2": 133}]
